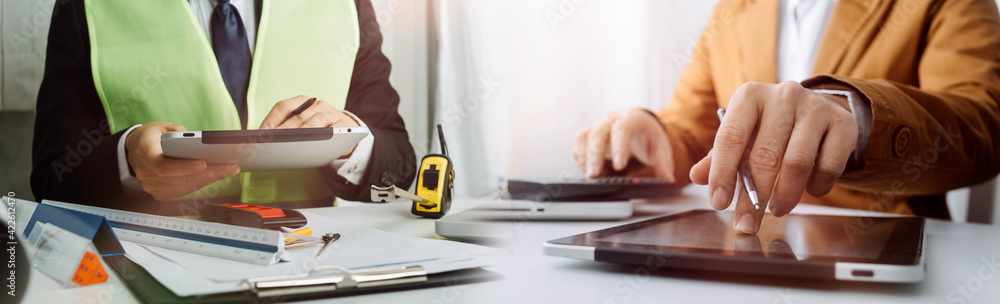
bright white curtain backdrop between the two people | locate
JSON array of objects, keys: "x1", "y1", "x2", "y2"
[{"x1": 436, "y1": 0, "x2": 717, "y2": 197}]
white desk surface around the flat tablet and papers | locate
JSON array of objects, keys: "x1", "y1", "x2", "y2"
[{"x1": 15, "y1": 186, "x2": 1000, "y2": 304}]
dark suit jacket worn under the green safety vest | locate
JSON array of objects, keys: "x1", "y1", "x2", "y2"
[{"x1": 31, "y1": 0, "x2": 416, "y2": 212}]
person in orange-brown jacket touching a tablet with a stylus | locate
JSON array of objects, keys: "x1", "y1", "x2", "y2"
[{"x1": 573, "y1": 0, "x2": 1000, "y2": 233}]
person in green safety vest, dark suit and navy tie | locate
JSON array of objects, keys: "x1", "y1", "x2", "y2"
[{"x1": 31, "y1": 0, "x2": 416, "y2": 215}]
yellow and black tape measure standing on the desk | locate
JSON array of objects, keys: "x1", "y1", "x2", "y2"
[{"x1": 410, "y1": 124, "x2": 455, "y2": 219}]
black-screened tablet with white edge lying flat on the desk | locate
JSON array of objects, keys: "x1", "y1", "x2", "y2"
[{"x1": 544, "y1": 210, "x2": 925, "y2": 283}]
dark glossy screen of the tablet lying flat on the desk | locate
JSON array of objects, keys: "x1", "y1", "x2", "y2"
[{"x1": 560, "y1": 210, "x2": 922, "y2": 264}]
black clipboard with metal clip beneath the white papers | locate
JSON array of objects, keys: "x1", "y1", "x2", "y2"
[{"x1": 104, "y1": 255, "x2": 503, "y2": 304}]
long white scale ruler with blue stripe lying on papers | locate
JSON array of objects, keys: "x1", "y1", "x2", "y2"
[{"x1": 42, "y1": 200, "x2": 285, "y2": 265}]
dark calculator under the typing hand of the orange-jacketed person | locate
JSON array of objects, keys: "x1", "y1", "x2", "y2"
[{"x1": 505, "y1": 177, "x2": 678, "y2": 202}]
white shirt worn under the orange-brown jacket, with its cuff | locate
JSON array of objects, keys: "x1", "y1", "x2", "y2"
[{"x1": 778, "y1": 0, "x2": 872, "y2": 162}]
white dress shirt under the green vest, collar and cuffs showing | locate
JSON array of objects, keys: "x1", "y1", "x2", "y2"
[{"x1": 118, "y1": 0, "x2": 375, "y2": 196}]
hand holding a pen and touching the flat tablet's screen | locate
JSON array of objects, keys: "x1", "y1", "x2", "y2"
[{"x1": 691, "y1": 82, "x2": 858, "y2": 234}]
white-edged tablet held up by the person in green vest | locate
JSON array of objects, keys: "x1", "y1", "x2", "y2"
[{"x1": 160, "y1": 127, "x2": 369, "y2": 172}]
